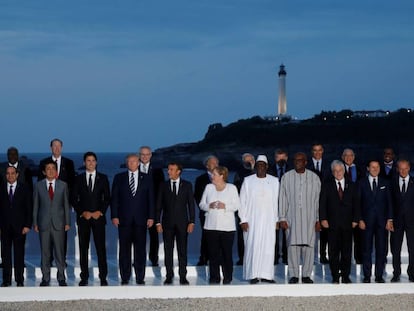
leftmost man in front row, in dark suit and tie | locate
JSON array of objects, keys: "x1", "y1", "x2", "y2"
[{"x1": 0, "y1": 166, "x2": 33, "y2": 287}]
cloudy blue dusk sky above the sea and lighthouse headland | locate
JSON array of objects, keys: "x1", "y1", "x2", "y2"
[{"x1": 0, "y1": 0, "x2": 414, "y2": 152}]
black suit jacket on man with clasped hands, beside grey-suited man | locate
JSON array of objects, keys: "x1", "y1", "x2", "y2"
[{"x1": 71, "y1": 172, "x2": 110, "y2": 223}]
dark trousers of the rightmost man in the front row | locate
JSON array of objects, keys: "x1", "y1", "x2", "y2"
[{"x1": 391, "y1": 217, "x2": 414, "y2": 280}]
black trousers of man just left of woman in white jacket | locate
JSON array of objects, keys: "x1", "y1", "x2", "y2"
[{"x1": 163, "y1": 225, "x2": 188, "y2": 279}]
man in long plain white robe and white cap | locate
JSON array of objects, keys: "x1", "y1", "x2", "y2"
[{"x1": 239, "y1": 155, "x2": 279, "y2": 284}]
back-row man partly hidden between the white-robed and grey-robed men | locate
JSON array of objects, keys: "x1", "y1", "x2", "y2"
[{"x1": 269, "y1": 149, "x2": 289, "y2": 265}]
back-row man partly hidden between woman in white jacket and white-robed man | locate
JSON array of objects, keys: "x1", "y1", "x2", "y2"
[{"x1": 233, "y1": 153, "x2": 256, "y2": 266}]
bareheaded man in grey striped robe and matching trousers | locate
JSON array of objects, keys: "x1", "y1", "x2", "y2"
[{"x1": 279, "y1": 152, "x2": 321, "y2": 284}]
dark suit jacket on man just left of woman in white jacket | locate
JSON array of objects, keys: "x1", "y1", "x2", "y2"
[{"x1": 155, "y1": 178, "x2": 195, "y2": 230}]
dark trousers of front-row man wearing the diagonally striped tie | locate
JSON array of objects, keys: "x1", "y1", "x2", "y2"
[{"x1": 118, "y1": 225, "x2": 147, "y2": 281}]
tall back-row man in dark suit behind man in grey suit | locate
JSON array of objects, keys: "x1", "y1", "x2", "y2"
[{"x1": 37, "y1": 138, "x2": 76, "y2": 265}]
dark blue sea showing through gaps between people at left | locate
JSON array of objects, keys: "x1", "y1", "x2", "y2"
[{"x1": 0, "y1": 152, "x2": 237, "y2": 265}]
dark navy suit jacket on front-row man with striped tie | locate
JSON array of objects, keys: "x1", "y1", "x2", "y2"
[{"x1": 111, "y1": 170, "x2": 155, "y2": 226}]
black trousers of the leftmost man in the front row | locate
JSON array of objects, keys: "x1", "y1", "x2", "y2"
[{"x1": 1, "y1": 226, "x2": 26, "y2": 284}]
